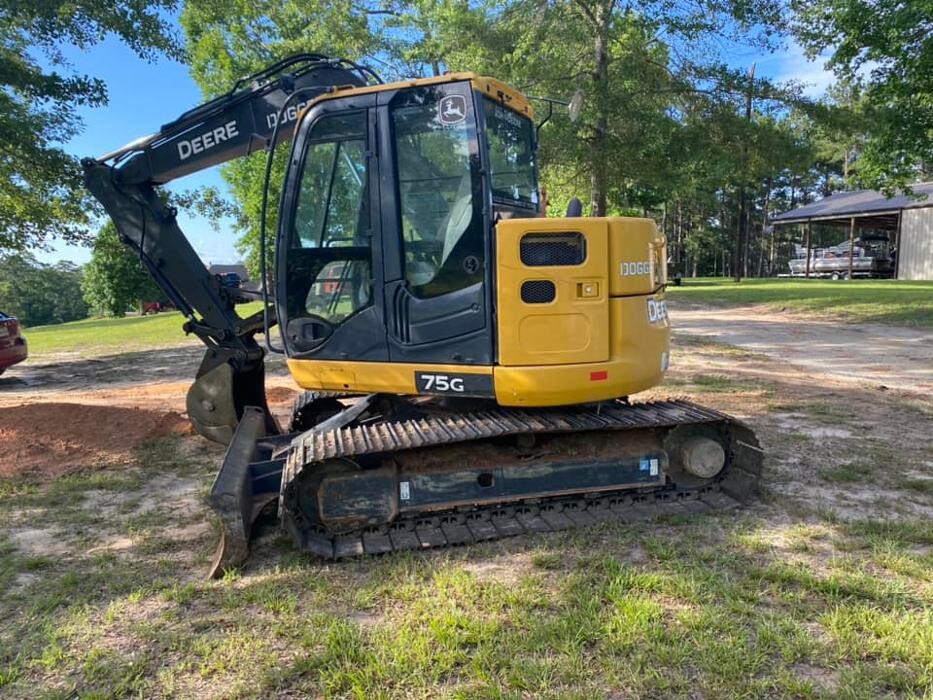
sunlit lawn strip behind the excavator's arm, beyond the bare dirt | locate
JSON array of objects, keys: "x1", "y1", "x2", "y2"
[{"x1": 24, "y1": 302, "x2": 262, "y2": 357}]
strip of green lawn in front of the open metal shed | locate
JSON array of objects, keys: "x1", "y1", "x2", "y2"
[{"x1": 668, "y1": 277, "x2": 933, "y2": 328}]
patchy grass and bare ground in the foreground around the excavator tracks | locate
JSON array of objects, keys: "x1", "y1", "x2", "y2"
[{"x1": 0, "y1": 345, "x2": 933, "y2": 700}]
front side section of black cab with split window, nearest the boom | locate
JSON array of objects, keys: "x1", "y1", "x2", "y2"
[{"x1": 276, "y1": 95, "x2": 389, "y2": 361}]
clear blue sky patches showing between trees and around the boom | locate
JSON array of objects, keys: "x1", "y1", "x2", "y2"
[{"x1": 37, "y1": 16, "x2": 831, "y2": 264}]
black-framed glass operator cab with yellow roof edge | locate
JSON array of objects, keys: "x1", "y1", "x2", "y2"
[{"x1": 276, "y1": 74, "x2": 539, "y2": 372}]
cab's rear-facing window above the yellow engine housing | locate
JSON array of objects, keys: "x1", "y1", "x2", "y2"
[{"x1": 485, "y1": 98, "x2": 538, "y2": 208}]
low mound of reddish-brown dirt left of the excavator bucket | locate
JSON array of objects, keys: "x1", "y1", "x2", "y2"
[{"x1": 0, "y1": 403, "x2": 191, "y2": 476}]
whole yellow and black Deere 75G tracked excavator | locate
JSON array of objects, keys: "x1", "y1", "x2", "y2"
[{"x1": 83, "y1": 54, "x2": 762, "y2": 575}]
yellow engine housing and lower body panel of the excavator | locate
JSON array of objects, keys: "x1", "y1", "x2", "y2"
[{"x1": 288, "y1": 217, "x2": 670, "y2": 407}]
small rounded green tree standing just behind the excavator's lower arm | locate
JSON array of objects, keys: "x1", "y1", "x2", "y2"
[{"x1": 81, "y1": 221, "x2": 162, "y2": 316}]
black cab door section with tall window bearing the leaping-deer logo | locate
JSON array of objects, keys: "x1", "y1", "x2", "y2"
[{"x1": 379, "y1": 81, "x2": 493, "y2": 365}]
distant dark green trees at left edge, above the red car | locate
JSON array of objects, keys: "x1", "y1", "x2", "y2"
[{"x1": 0, "y1": 253, "x2": 87, "y2": 326}]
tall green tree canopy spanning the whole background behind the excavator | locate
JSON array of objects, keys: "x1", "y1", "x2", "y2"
[{"x1": 7, "y1": 0, "x2": 920, "y2": 284}]
